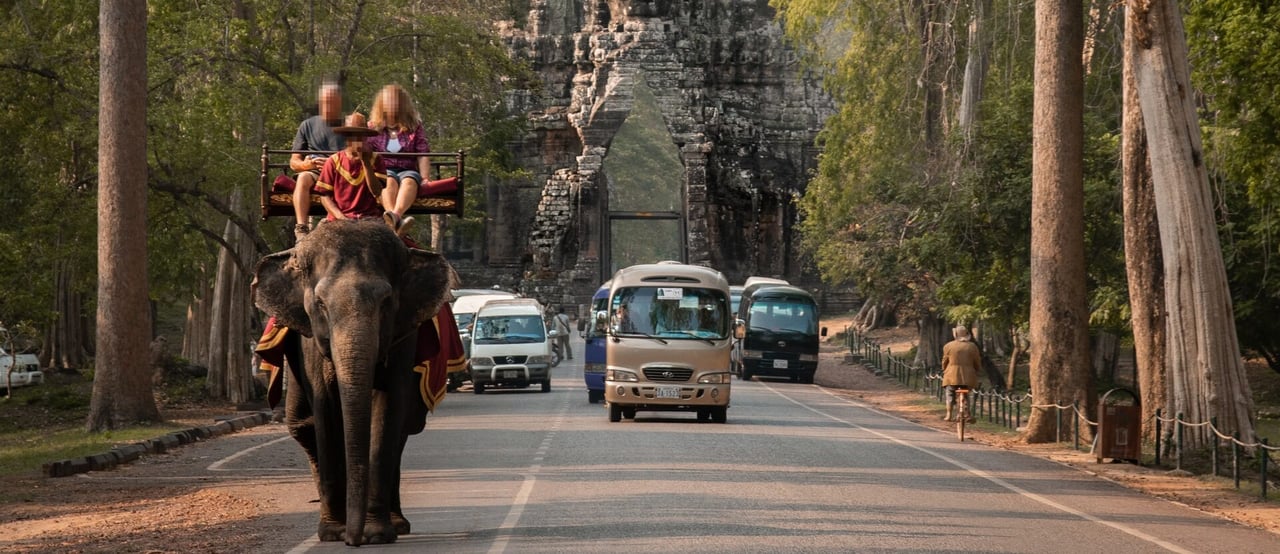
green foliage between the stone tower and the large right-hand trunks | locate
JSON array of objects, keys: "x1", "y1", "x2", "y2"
[{"x1": 773, "y1": 0, "x2": 1126, "y2": 326}]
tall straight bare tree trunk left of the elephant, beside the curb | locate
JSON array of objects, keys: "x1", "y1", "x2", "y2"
[{"x1": 86, "y1": 0, "x2": 160, "y2": 431}]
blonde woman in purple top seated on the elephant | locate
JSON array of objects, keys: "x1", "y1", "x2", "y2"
[{"x1": 366, "y1": 83, "x2": 431, "y2": 234}]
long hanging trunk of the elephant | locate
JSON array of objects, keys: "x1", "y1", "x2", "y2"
[{"x1": 334, "y1": 330, "x2": 378, "y2": 546}]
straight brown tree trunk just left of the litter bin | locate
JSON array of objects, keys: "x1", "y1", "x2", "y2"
[{"x1": 1025, "y1": 0, "x2": 1096, "y2": 443}]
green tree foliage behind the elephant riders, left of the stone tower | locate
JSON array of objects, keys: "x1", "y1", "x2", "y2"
[{"x1": 0, "y1": 0, "x2": 531, "y2": 325}]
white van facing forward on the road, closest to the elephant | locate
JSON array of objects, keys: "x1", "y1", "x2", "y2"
[{"x1": 471, "y1": 298, "x2": 556, "y2": 394}]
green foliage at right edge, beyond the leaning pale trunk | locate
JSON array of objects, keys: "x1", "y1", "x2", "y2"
[{"x1": 1187, "y1": 0, "x2": 1280, "y2": 371}]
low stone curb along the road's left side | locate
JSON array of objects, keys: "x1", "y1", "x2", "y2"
[{"x1": 42, "y1": 411, "x2": 271, "y2": 477}]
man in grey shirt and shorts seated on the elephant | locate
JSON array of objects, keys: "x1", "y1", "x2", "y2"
[{"x1": 289, "y1": 83, "x2": 347, "y2": 239}]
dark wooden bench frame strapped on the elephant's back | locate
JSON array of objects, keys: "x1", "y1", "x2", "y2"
[{"x1": 259, "y1": 145, "x2": 466, "y2": 221}]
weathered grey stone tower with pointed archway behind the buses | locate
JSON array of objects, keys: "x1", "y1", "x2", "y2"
[{"x1": 485, "y1": 0, "x2": 835, "y2": 310}]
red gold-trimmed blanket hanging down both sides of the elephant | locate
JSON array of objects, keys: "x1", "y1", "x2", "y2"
[{"x1": 255, "y1": 303, "x2": 467, "y2": 412}]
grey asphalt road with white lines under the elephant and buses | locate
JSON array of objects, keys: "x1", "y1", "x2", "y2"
[{"x1": 172, "y1": 343, "x2": 1280, "y2": 553}]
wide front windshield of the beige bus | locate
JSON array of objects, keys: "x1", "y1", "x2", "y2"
[{"x1": 609, "y1": 287, "x2": 730, "y2": 339}]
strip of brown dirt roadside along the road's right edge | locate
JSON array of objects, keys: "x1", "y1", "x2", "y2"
[{"x1": 814, "y1": 321, "x2": 1280, "y2": 534}]
